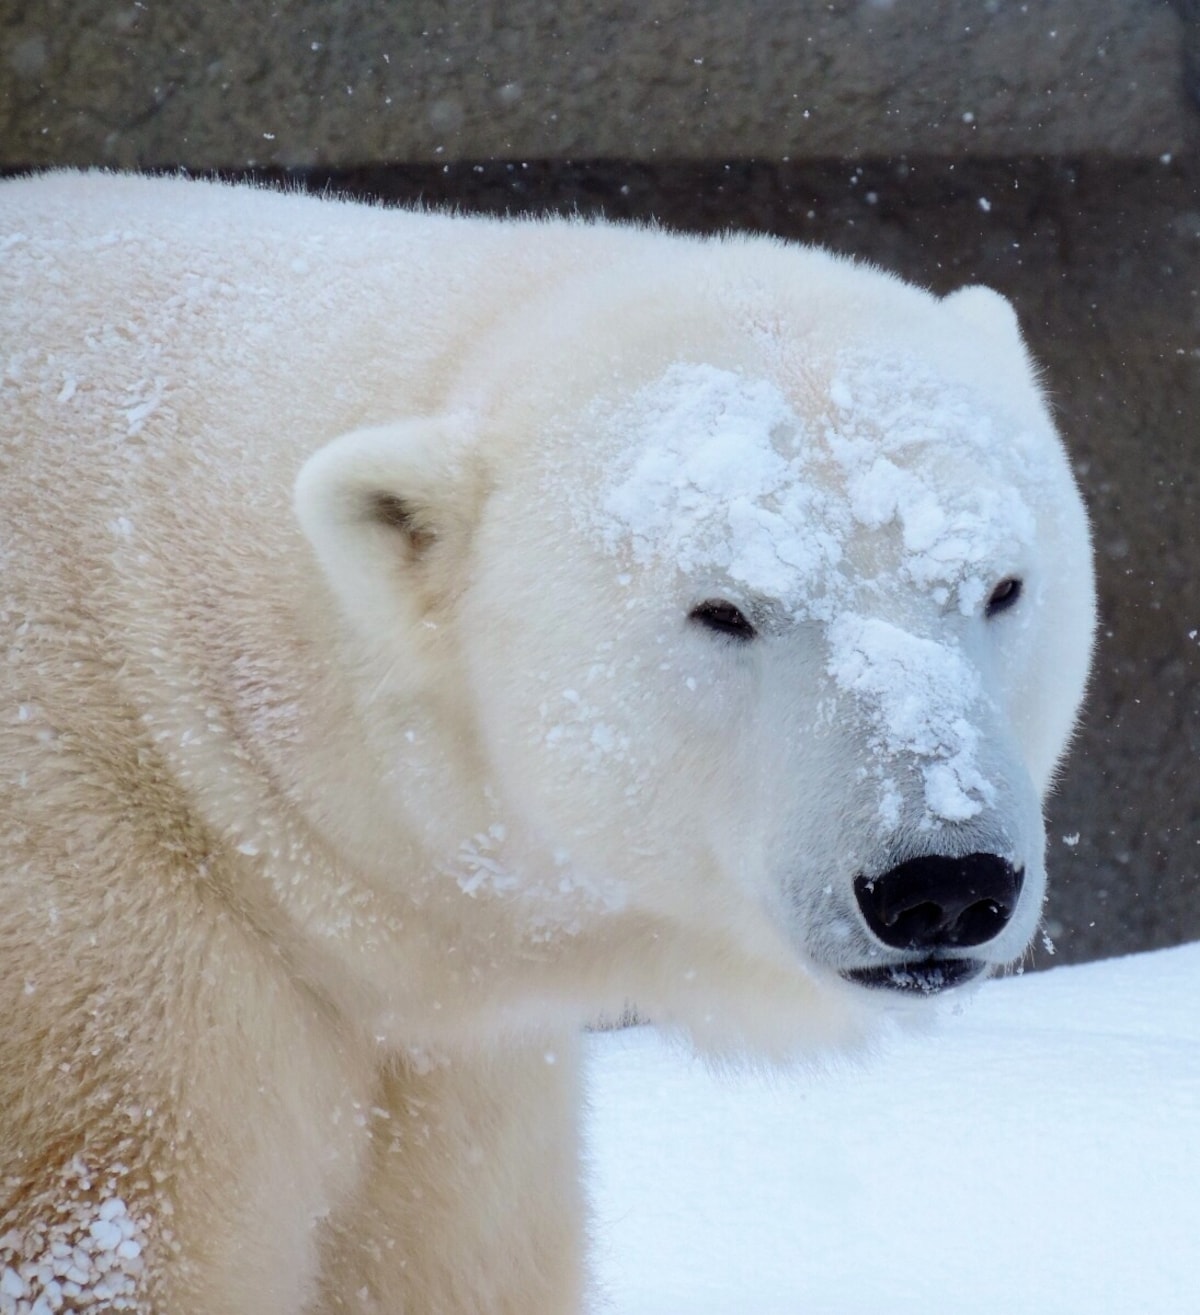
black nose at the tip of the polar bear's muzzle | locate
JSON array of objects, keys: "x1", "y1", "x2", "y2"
[{"x1": 854, "y1": 853, "x2": 1025, "y2": 951}]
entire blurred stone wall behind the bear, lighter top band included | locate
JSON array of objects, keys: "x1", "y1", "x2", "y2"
[{"x1": 0, "y1": 0, "x2": 1200, "y2": 964}]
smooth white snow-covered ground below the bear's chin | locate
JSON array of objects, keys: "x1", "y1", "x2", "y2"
[{"x1": 589, "y1": 944, "x2": 1200, "y2": 1315}]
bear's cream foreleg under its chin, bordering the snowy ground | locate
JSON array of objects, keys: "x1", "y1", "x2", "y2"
[{"x1": 318, "y1": 1036, "x2": 584, "y2": 1315}]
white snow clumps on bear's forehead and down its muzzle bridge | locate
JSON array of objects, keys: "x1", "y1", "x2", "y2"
[{"x1": 580, "y1": 352, "x2": 1045, "y2": 828}]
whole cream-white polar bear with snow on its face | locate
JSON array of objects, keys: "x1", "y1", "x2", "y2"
[{"x1": 0, "y1": 174, "x2": 1094, "y2": 1315}]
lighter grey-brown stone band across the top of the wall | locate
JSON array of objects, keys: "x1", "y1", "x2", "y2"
[{"x1": 0, "y1": 0, "x2": 1196, "y2": 170}]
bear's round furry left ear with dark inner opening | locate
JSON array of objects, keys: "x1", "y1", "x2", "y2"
[{"x1": 294, "y1": 416, "x2": 484, "y2": 635}]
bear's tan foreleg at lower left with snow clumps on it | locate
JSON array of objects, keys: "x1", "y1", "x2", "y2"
[{"x1": 0, "y1": 864, "x2": 373, "y2": 1315}]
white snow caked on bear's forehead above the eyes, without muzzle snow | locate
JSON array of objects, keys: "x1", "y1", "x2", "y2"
[{"x1": 599, "y1": 352, "x2": 1034, "y2": 611}]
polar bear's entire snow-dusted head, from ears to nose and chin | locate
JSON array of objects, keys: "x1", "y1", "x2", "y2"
[{"x1": 298, "y1": 243, "x2": 1094, "y2": 1052}]
